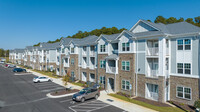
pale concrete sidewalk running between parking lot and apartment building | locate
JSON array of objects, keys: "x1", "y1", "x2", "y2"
[{"x1": 27, "y1": 70, "x2": 157, "y2": 112}]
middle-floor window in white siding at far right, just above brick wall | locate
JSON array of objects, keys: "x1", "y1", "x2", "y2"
[{"x1": 177, "y1": 63, "x2": 191, "y2": 74}]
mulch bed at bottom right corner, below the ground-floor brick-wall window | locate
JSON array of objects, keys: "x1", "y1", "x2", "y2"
[{"x1": 170, "y1": 101, "x2": 195, "y2": 112}]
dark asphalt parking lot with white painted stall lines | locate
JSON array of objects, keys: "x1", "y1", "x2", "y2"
[{"x1": 0, "y1": 66, "x2": 124, "y2": 112}]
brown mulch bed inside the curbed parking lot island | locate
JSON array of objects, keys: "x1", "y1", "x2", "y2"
[{"x1": 50, "y1": 89, "x2": 79, "y2": 96}]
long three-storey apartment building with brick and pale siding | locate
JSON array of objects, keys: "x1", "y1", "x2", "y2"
[{"x1": 10, "y1": 20, "x2": 200, "y2": 105}]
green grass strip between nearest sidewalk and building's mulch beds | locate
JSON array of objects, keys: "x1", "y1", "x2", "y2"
[{"x1": 109, "y1": 94, "x2": 184, "y2": 112}]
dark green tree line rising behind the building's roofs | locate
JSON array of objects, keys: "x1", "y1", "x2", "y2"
[{"x1": 34, "y1": 16, "x2": 200, "y2": 46}]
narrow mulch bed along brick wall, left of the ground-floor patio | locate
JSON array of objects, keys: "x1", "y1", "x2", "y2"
[{"x1": 133, "y1": 97, "x2": 171, "y2": 107}]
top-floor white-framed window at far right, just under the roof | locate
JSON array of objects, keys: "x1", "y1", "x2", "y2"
[{"x1": 177, "y1": 39, "x2": 191, "y2": 50}]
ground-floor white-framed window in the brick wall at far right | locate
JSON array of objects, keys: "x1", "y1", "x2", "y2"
[{"x1": 176, "y1": 86, "x2": 191, "y2": 99}]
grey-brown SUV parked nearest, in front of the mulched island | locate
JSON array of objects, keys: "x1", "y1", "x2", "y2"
[{"x1": 72, "y1": 87, "x2": 100, "y2": 102}]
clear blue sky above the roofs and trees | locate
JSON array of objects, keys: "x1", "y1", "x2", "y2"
[{"x1": 0, "y1": 0, "x2": 200, "y2": 49}]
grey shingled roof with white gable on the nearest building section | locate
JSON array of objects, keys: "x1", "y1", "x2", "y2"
[{"x1": 129, "y1": 20, "x2": 200, "y2": 38}]
